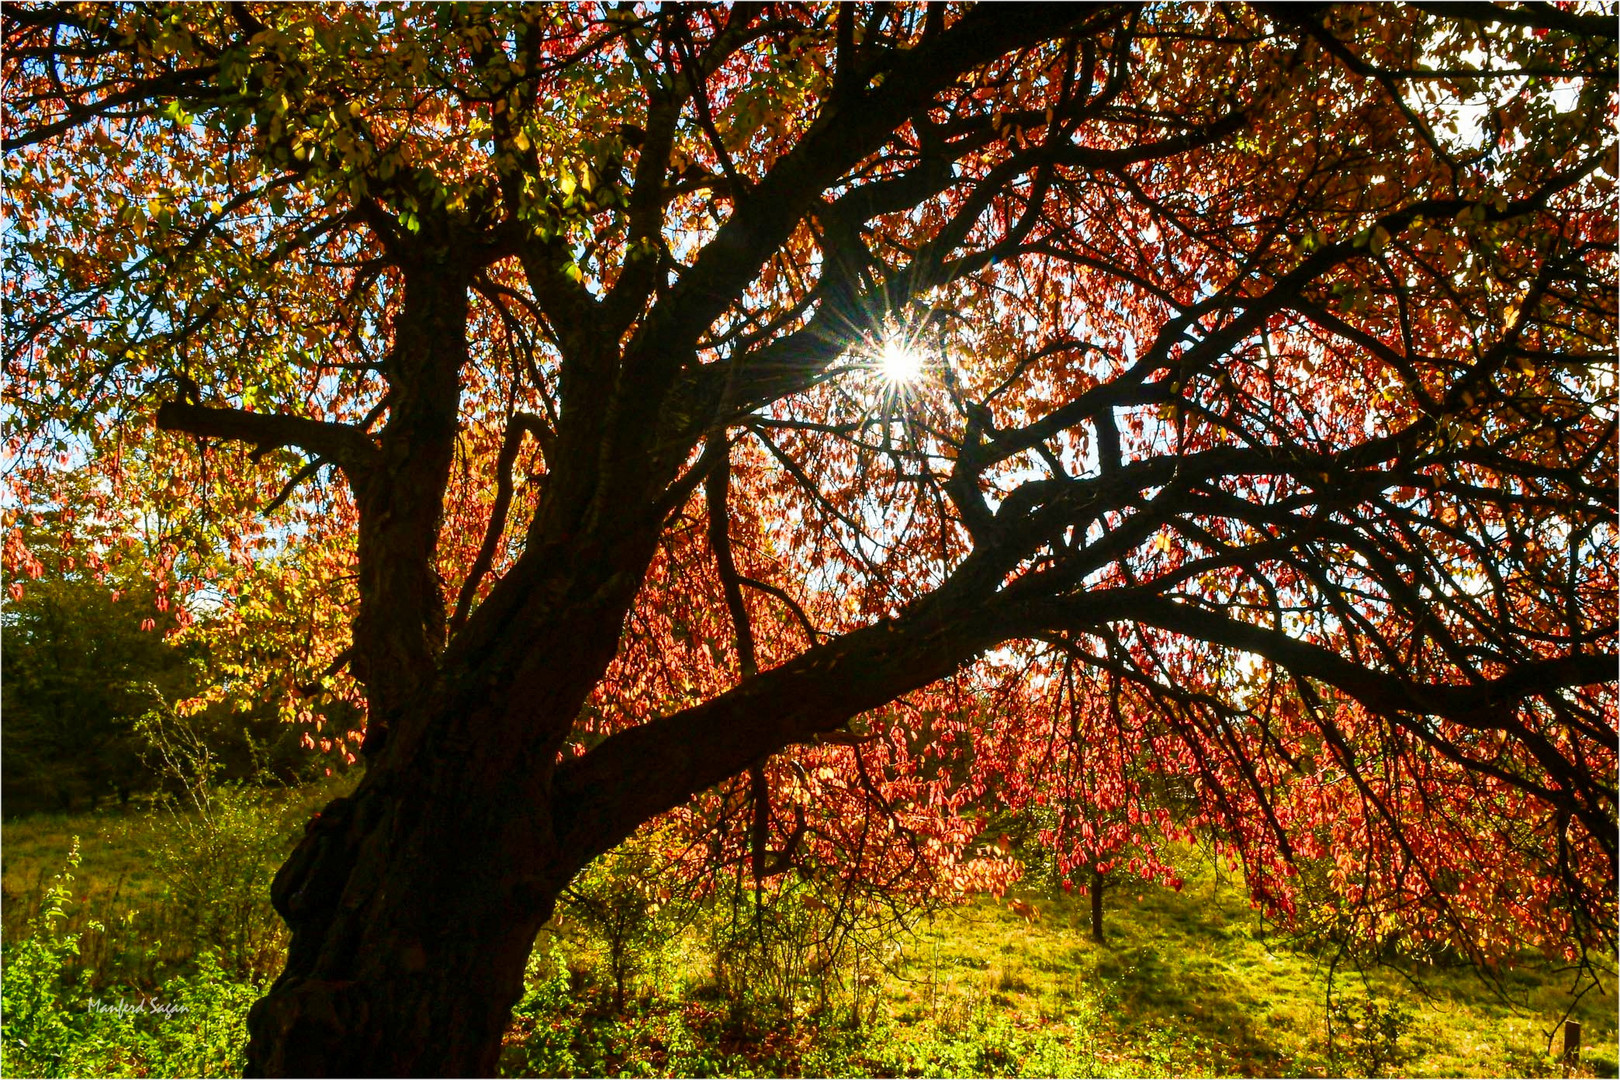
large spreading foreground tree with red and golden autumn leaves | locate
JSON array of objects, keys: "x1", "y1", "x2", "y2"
[{"x1": 5, "y1": 3, "x2": 1615, "y2": 1075}]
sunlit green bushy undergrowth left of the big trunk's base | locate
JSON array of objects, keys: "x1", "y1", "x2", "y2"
[{"x1": 0, "y1": 714, "x2": 298, "y2": 1077}]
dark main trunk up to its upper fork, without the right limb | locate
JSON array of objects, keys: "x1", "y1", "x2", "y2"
[{"x1": 248, "y1": 537, "x2": 654, "y2": 1075}]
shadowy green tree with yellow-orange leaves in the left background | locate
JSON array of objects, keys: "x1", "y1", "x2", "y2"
[{"x1": 0, "y1": 473, "x2": 358, "y2": 814}]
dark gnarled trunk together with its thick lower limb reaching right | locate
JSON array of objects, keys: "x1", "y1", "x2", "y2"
[{"x1": 248, "y1": 472, "x2": 1021, "y2": 1077}]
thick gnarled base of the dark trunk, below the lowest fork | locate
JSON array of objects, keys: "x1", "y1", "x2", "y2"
[{"x1": 248, "y1": 696, "x2": 575, "y2": 1077}]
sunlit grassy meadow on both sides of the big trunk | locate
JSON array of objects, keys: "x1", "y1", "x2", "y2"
[{"x1": 3, "y1": 787, "x2": 1617, "y2": 1077}]
